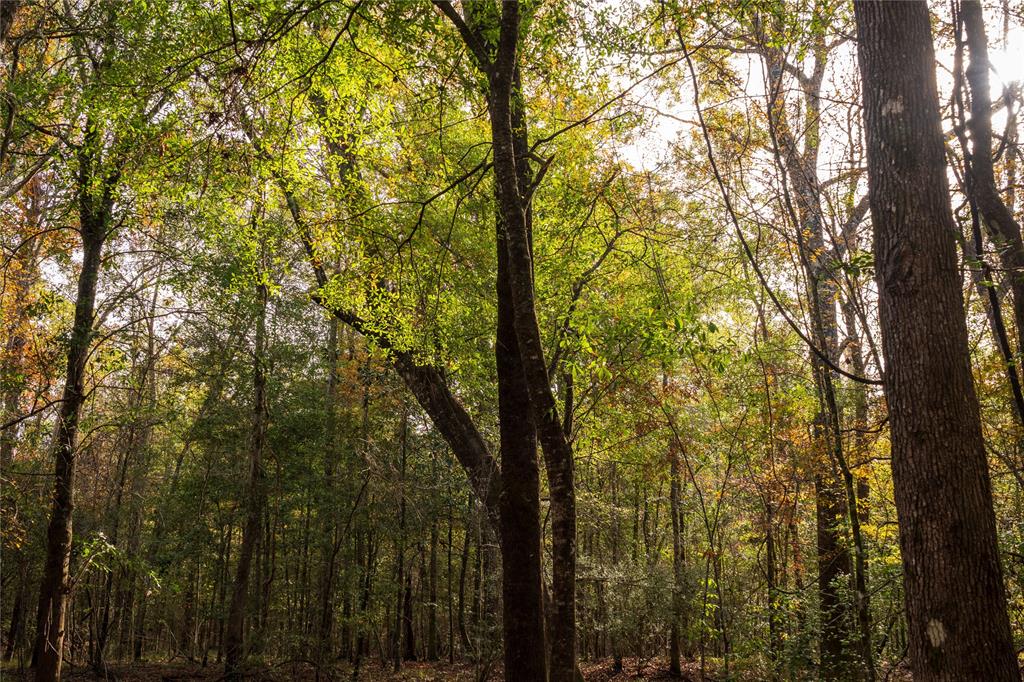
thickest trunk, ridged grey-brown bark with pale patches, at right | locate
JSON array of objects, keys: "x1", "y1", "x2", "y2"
[{"x1": 854, "y1": 0, "x2": 1020, "y2": 680}]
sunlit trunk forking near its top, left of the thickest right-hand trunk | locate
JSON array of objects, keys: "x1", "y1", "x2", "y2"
[{"x1": 758, "y1": 25, "x2": 874, "y2": 680}]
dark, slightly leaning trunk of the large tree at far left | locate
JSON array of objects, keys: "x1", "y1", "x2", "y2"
[{"x1": 33, "y1": 129, "x2": 120, "y2": 682}]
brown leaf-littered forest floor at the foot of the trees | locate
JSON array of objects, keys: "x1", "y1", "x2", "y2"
[{"x1": 0, "y1": 658, "x2": 733, "y2": 682}]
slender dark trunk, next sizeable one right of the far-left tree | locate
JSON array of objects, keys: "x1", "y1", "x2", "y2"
[{"x1": 224, "y1": 284, "x2": 267, "y2": 680}]
